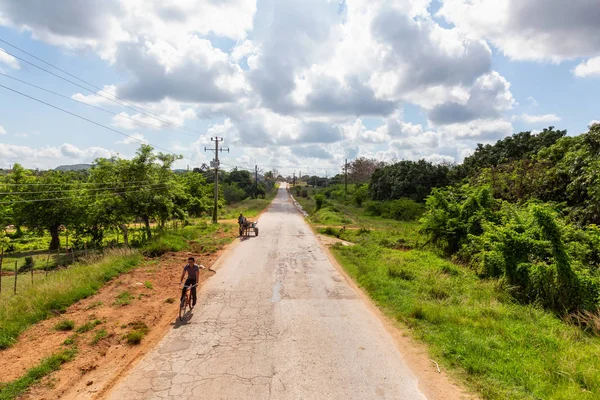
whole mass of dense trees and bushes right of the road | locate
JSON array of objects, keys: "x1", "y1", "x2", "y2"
[{"x1": 296, "y1": 125, "x2": 600, "y2": 318}]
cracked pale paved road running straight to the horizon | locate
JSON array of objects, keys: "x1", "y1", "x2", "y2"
[{"x1": 108, "y1": 187, "x2": 425, "y2": 400}]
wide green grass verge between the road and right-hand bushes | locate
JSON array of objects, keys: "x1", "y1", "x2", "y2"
[{"x1": 333, "y1": 243, "x2": 600, "y2": 399}]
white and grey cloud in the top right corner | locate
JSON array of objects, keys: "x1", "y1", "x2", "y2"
[{"x1": 438, "y1": 0, "x2": 600, "y2": 62}]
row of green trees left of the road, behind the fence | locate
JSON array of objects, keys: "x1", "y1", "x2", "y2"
[{"x1": 0, "y1": 145, "x2": 274, "y2": 251}]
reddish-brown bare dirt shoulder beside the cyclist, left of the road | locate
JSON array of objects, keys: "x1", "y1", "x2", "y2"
[{"x1": 0, "y1": 233, "x2": 235, "y2": 399}]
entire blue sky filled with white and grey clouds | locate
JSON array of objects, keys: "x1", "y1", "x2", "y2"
[{"x1": 0, "y1": 0, "x2": 600, "y2": 175}]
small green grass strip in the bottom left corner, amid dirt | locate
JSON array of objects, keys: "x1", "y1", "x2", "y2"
[{"x1": 0, "y1": 348, "x2": 77, "y2": 400}]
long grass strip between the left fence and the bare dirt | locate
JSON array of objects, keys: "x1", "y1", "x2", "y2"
[{"x1": 0, "y1": 250, "x2": 141, "y2": 349}]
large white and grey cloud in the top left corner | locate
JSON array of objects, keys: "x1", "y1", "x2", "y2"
[{"x1": 0, "y1": 0, "x2": 256, "y2": 62}]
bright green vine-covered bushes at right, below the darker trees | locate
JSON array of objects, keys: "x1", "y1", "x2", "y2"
[{"x1": 422, "y1": 186, "x2": 600, "y2": 314}]
